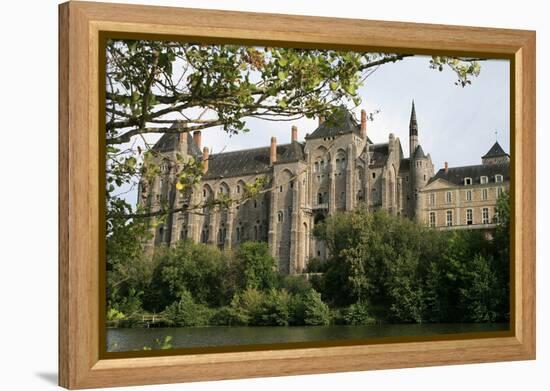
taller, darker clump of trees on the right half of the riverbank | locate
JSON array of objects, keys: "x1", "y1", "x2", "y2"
[{"x1": 313, "y1": 191, "x2": 509, "y2": 323}]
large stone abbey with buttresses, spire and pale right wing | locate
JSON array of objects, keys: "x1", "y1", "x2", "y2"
[{"x1": 138, "y1": 102, "x2": 509, "y2": 274}]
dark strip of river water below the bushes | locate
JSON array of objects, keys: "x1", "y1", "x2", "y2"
[{"x1": 107, "y1": 323, "x2": 510, "y2": 352}]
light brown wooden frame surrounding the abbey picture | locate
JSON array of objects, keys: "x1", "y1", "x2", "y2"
[{"x1": 59, "y1": 1, "x2": 535, "y2": 389}]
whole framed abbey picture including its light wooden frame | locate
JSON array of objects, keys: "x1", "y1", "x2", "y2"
[{"x1": 59, "y1": 2, "x2": 535, "y2": 389}]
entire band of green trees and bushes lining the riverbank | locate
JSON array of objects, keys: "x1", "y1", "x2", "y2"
[{"x1": 107, "y1": 194, "x2": 509, "y2": 326}]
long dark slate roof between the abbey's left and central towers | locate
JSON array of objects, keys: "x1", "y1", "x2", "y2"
[{"x1": 204, "y1": 142, "x2": 304, "y2": 179}]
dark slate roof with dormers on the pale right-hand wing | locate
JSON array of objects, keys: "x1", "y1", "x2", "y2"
[{"x1": 428, "y1": 163, "x2": 510, "y2": 185}]
